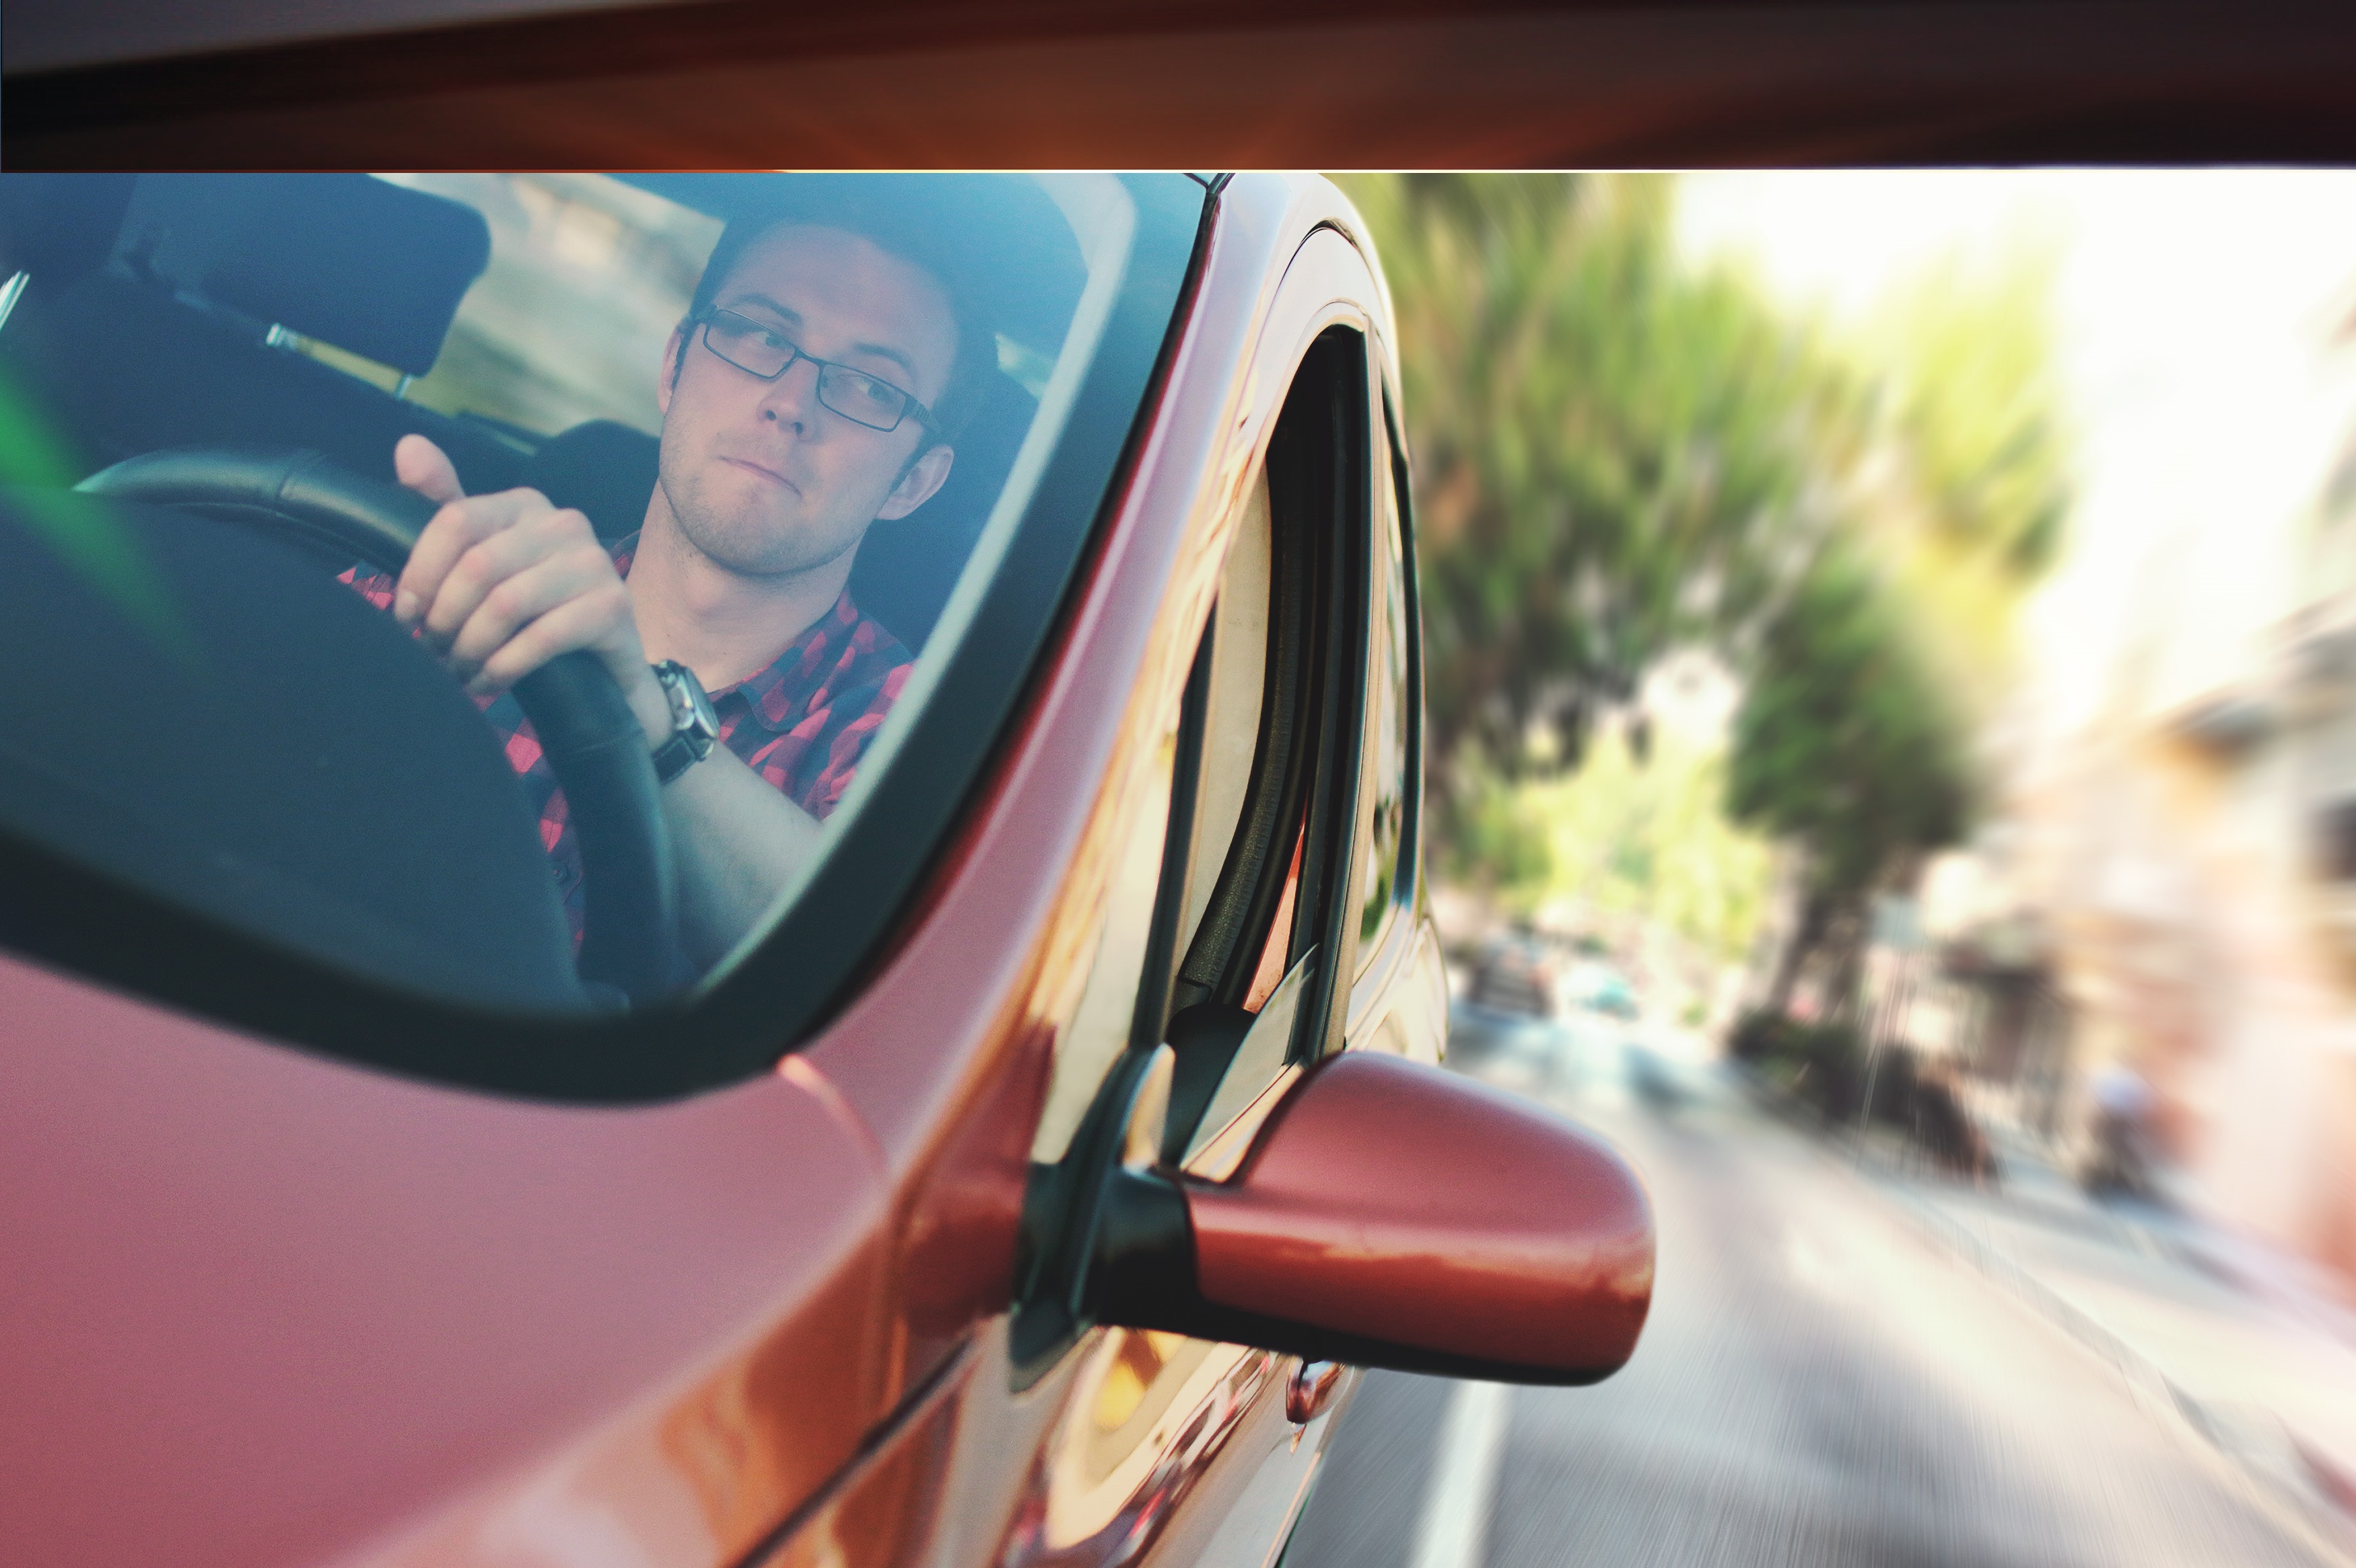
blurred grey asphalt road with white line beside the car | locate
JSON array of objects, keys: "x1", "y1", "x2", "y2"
[{"x1": 1284, "y1": 1020, "x2": 2332, "y2": 1568}]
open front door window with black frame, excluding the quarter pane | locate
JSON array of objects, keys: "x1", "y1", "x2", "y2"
[{"x1": 1162, "y1": 330, "x2": 1371, "y2": 1170}]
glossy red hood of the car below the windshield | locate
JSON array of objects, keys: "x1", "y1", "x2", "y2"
[{"x1": 0, "y1": 958, "x2": 884, "y2": 1568}]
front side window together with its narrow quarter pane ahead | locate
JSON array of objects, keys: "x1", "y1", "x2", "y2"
[{"x1": 1032, "y1": 327, "x2": 1388, "y2": 1163}]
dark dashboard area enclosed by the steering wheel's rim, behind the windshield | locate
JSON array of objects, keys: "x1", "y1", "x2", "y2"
[{"x1": 0, "y1": 490, "x2": 592, "y2": 1012}]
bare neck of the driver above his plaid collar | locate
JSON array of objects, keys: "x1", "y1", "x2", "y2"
[{"x1": 629, "y1": 501, "x2": 858, "y2": 690}]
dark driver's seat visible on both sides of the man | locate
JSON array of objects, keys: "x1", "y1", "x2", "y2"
[{"x1": 523, "y1": 372, "x2": 1039, "y2": 652}]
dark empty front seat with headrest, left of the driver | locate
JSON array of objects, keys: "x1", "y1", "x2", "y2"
[{"x1": 0, "y1": 174, "x2": 523, "y2": 490}]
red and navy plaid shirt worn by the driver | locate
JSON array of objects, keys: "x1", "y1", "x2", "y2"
[{"x1": 344, "y1": 534, "x2": 909, "y2": 944}]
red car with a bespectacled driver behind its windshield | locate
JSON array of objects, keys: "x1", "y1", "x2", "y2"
[{"x1": 0, "y1": 174, "x2": 1652, "y2": 1568}]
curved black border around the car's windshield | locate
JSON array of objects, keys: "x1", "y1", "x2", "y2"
[{"x1": 0, "y1": 174, "x2": 1218, "y2": 1104}]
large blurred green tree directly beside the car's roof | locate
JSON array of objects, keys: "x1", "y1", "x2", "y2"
[{"x1": 1341, "y1": 174, "x2": 1864, "y2": 810}]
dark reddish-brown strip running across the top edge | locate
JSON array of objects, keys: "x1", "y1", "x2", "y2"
[{"x1": 13, "y1": 0, "x2": 2356, "y2": 167}]
